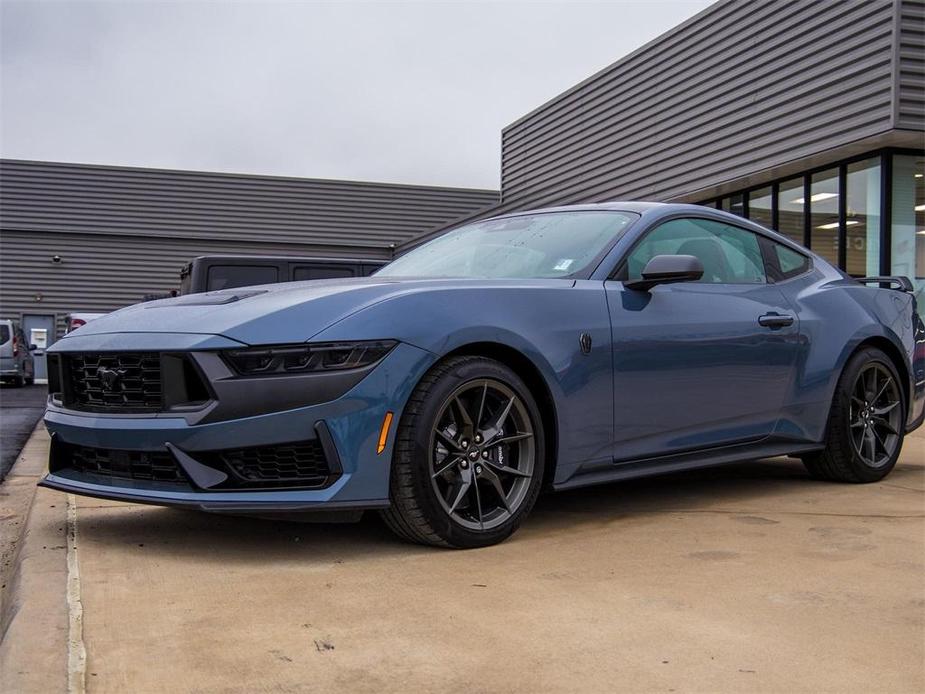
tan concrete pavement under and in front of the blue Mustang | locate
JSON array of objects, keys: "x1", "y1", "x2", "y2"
[{"x1": 0, "y1": 426, "x2": 925, "y2": 692}]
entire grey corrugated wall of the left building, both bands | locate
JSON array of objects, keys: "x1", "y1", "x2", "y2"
[{"x1": 0, "y1": 160, "x2": 498, "y2": 340}]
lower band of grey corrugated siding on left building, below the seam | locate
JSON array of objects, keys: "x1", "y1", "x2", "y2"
[{"x1": 0, "y1": 230, "x2": 388, "y2": 338}]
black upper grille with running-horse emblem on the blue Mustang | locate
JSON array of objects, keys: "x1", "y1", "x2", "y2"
[{"x1": 65, "y1": 352, "x2": 162, "y2": 412}]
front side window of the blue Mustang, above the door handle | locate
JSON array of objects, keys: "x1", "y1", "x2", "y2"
[{"x1": 626, "y1": 218, "x2": 767, "y2": 284}]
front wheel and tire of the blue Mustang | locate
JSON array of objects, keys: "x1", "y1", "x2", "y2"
[{"x1": 381, "y1": 356, "x2": 545, "y2": 549}]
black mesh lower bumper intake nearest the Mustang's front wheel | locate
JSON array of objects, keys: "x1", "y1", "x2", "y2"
[{"x1": 212, "y1": 441, "x2": 331, "y2": 487}]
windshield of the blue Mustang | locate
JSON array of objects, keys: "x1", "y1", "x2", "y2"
[{"x1": 376, "y1": 210, "x2": 638, "y2": 279}]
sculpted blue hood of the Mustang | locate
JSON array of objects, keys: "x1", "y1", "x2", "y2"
[{"x1": 59, "y1": 277, "x2": 563, "y2": 349}]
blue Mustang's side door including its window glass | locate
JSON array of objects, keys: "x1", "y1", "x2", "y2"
[{"x1": 606, "y1": 217, "x2": 799, "y2": 461}]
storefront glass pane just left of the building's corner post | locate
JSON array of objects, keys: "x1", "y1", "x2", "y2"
[{"x1": 845, "y1": 158, "x2": 880, "y2": 277}]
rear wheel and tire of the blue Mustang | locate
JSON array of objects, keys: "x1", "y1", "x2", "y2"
[{"x1": 803, "y1": 347, "x2": 906, "y2": 483}]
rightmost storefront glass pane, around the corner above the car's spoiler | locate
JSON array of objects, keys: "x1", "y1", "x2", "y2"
[{"x1": 890, "y1": 155, "x2": 925, "y2": 316}]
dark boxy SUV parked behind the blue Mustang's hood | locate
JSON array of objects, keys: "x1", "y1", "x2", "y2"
[{"x1": 180, "y1": 255, "x2": 385, "y2": 294}]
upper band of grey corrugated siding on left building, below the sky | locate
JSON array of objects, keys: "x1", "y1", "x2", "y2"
[{"x1": 0, "y1": 160, "x2": 498, "y2": 249}]
